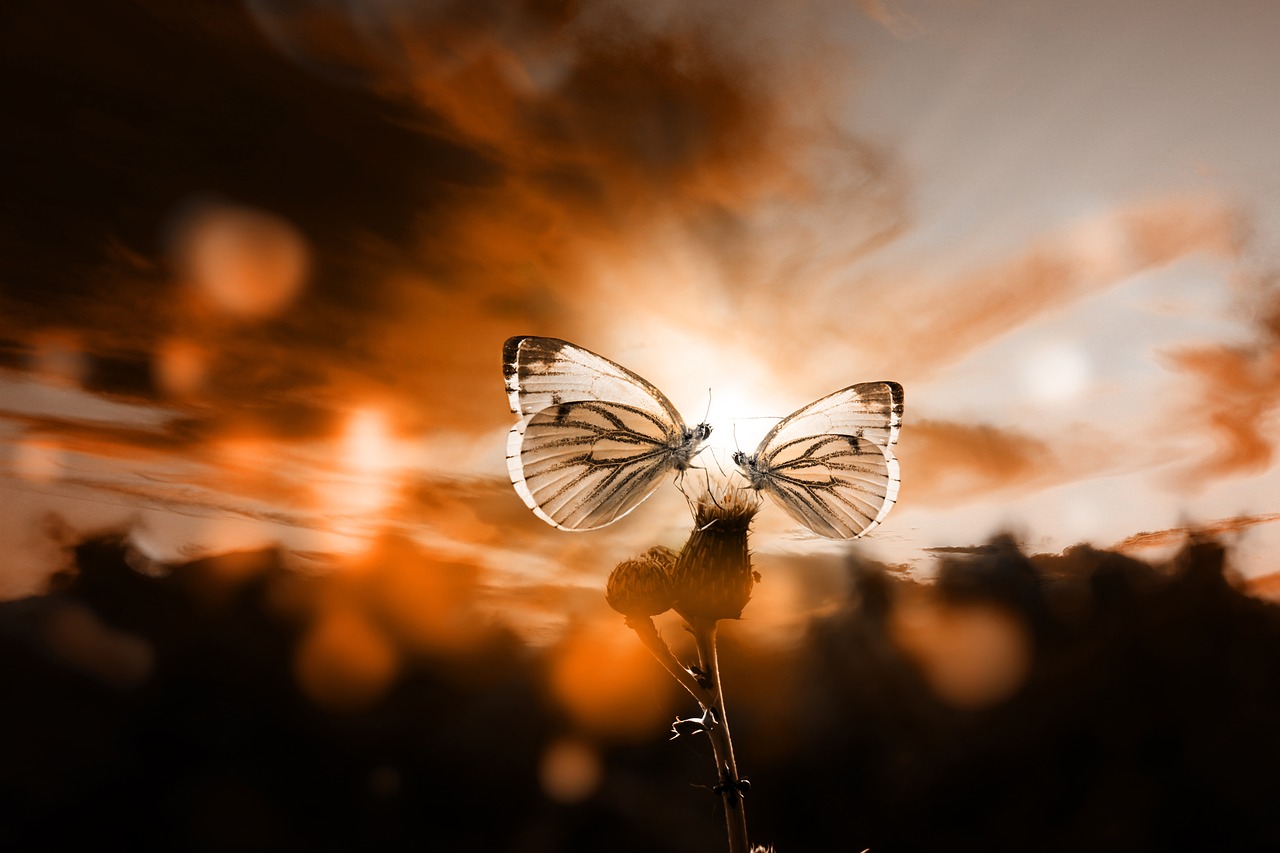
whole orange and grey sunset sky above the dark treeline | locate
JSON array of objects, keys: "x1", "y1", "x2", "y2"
[{"x1": 0, "y1": 0, "x2": 1280, "y2": 637}]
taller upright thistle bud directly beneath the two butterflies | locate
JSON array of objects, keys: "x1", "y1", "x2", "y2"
[{"x1": 671, "y1": 491, "x2": 760, "y2": 621}]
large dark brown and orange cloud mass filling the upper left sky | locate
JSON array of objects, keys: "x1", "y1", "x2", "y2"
[{"x1": 0, "y1": 0, "x2": 901, "y2": 445}]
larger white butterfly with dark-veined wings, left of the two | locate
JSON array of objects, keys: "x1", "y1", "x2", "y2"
[{"x1": 502, "y1": 337, "x2": 712, "y2": 530}]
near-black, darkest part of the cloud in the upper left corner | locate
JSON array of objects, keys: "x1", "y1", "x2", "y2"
[{"x1": 4, "y1": 3, "x2": 483, "y2": 295}]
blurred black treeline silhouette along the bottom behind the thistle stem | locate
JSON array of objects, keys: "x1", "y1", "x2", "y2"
[{"x1": 0, "y1": 527, "x2": 1280, "y2": 853}]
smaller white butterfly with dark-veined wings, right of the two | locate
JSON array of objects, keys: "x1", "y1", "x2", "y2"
[{"x1": 733, "y1": 382, "x2": 902, "y2": 539}]
